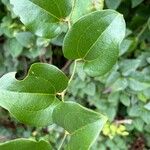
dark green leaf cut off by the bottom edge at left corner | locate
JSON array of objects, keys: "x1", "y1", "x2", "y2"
[{"x1": 0, "y1": 139, "x2": 52, "y2": 150}]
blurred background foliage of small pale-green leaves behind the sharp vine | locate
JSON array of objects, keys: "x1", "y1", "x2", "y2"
[{"x1": 0, "y1": 0, "x2": 150, "y2": 150}]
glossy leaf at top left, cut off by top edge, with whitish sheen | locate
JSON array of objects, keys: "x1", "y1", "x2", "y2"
[{"x1": 10, "y1": 0, "x2": 72, "y2": 38}]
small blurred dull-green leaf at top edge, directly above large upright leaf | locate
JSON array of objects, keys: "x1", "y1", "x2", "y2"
[{"x1": 105, "y1": 0, "x2": 122, "y2": 9}]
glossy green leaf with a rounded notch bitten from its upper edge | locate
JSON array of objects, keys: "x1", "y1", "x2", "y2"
[{"x1": 0, "y1": 63, "x2": 68, "y2": 126}]
